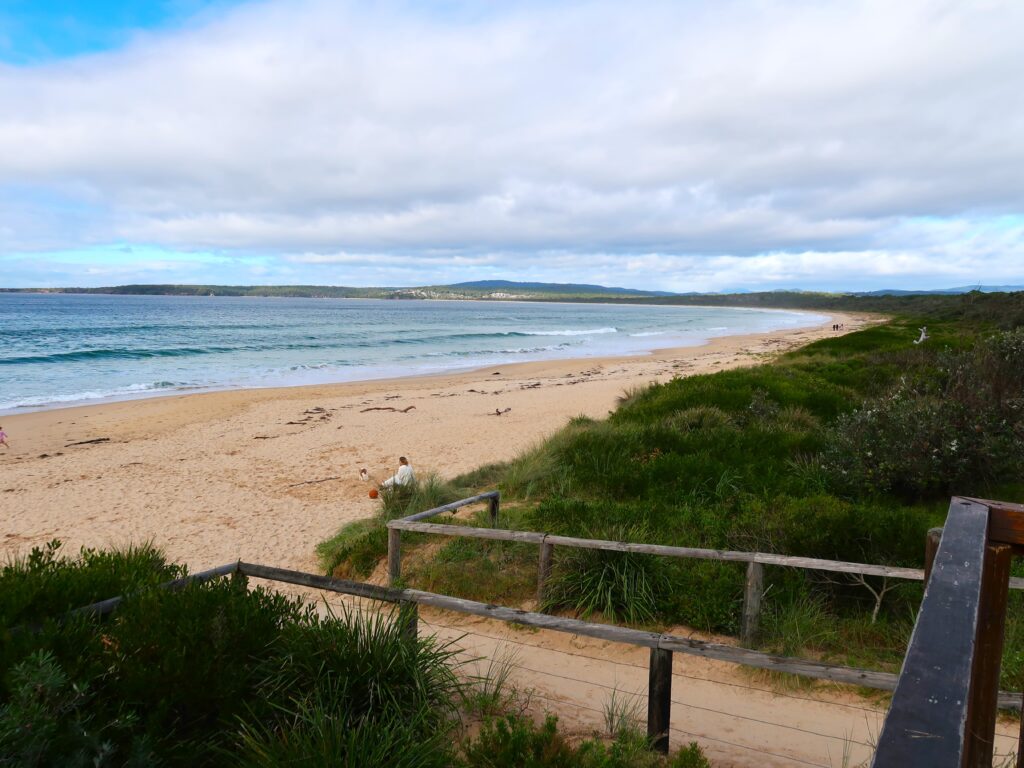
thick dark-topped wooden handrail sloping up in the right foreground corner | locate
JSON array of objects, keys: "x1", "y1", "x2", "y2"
[{"x1": 873, "y1": 498, "x2": 1024, "y2": 768}]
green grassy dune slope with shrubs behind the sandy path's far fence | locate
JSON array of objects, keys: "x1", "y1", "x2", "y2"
[{"x1": 328, "y1": 294, "x2": 1024, "y2": 688}]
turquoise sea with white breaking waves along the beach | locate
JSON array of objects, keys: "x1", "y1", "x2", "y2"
[{"x1": 0, "y1": 294, "x2": 826, "y2": 413}]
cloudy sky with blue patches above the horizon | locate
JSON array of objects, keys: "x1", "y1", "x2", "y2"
[{"x1": 0, "y1": 0, "x2": 1024, "y2": 291}]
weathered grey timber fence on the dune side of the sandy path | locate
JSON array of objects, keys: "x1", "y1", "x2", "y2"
[{"x1": 387, "y1": 490, "x2": 1024, "y2": 644}]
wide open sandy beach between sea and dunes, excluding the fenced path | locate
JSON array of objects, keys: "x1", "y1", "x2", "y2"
[{"x1": 0, "y1": 313, "x2": 878, "y2": 570}]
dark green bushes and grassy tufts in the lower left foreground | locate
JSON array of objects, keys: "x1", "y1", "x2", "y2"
[{"x1": 0, "y1": 548, "x2": 462, "y2": 768}]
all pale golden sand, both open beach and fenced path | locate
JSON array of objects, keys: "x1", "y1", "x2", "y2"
[{"x1": 8, "y1": 314, "x2": 954, "y2": 766}]
